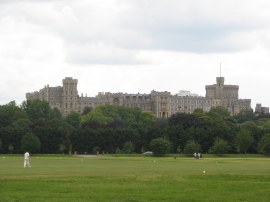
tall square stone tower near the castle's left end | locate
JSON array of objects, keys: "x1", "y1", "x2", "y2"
[{"x1": 61, "y1": 77, "x2": 78, "y2": 115}]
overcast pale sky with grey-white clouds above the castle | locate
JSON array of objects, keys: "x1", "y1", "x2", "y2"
[{"x1": 0, "y1": 0, "x2": 270, "y2": 108}]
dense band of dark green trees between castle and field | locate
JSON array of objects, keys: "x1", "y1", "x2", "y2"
[{"x1": 0, "y1": 100, "x2": 270, "y2": 155}]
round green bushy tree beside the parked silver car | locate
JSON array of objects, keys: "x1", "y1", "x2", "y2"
[{"x1": 150, "y1": 138, "x2": 170, "y2": 156}]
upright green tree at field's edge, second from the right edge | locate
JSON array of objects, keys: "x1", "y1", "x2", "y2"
[{"x1": 236, "y1": 128, "x2": 254, "y2": 154}]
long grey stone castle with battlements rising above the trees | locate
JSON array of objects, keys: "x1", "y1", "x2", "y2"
[{"x1": 26, "y1": 77, "x2": 251, "y2": 118}]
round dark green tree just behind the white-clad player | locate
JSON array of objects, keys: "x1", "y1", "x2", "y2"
[{"x1": 21, "y1": 133, "x2": 40, "y2": 153}]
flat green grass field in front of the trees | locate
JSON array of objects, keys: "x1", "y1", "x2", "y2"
[{"x1": 0, "y1": 155, "x2": 270, "y2": 202}]
